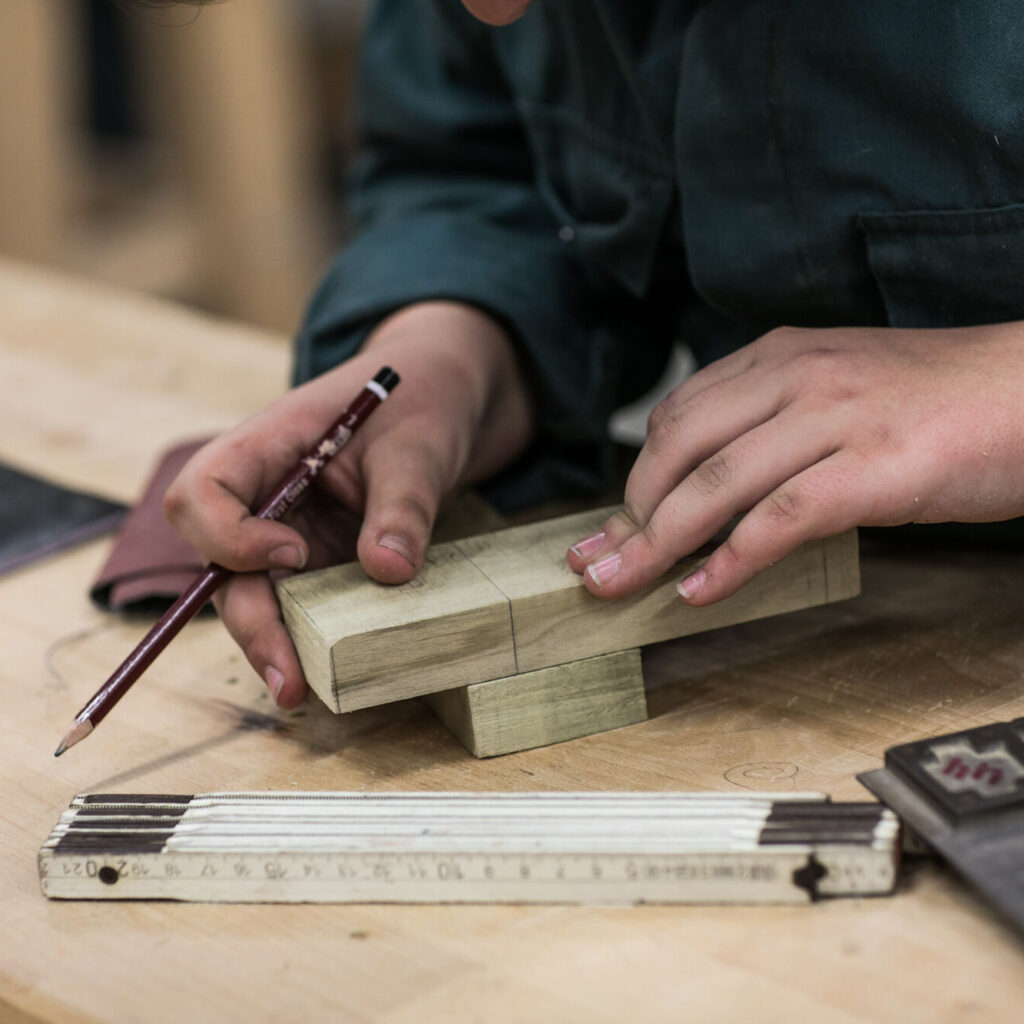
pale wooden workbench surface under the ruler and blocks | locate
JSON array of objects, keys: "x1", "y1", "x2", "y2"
[{"x1": 6, "y1": 263, "x2": 1024, "y2": 1024}]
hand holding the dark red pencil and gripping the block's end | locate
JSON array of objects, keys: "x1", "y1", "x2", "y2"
[{"x1": 164, "y1": 302, "x2": 532, "y2": 708}]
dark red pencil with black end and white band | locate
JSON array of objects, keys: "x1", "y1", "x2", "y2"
[{"x1": 53, "y1": 367, "x2": 398, "y2": 758}]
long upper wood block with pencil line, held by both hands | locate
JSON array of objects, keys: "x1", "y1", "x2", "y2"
[{"x1": 279, "y1": 509, "x2": 859, "y2": 711}]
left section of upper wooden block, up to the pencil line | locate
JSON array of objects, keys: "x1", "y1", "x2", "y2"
[{"x1": 278, "y1": 544, "x2": 516, "y2": 712}]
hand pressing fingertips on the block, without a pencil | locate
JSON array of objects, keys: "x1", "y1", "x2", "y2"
[{"x1": 568, "y1": 324, "x2": 1024, "y2": 605}]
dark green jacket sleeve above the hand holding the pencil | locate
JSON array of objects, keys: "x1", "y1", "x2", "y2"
[{"x1": 295, "y1": 0, "x2": 663, "y2": 509}]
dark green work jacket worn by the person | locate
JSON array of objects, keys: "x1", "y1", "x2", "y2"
[{"x1": 297, "y1": 0, "x2": 1024, "y2": 520}]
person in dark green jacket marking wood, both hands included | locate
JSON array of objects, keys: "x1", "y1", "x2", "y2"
[{"x1": 166, "y1": 0, "x2": 1024, "y2": 708}]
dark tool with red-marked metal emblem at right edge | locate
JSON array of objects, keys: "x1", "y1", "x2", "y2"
[{"x1": 857, "y1": 718, "x2": 1024, "y2": 931}]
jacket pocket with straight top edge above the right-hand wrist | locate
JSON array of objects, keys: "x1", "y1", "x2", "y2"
[{"x1": 858, "y1": 205, "x2": 1024, "y2": 328}]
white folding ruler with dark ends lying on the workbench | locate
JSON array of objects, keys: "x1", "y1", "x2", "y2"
[{"x1": 39, "y1": 792, "x2": 899, "y2": 903}]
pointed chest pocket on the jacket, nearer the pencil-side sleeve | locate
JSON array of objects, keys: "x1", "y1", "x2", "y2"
[{"x1": 519, "y1": 100, "x2": 674, "y2": 296}]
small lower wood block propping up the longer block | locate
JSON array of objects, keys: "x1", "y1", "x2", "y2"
[{"x1": 424, "y1": 647, "x2": 647, "y2": 758}]
